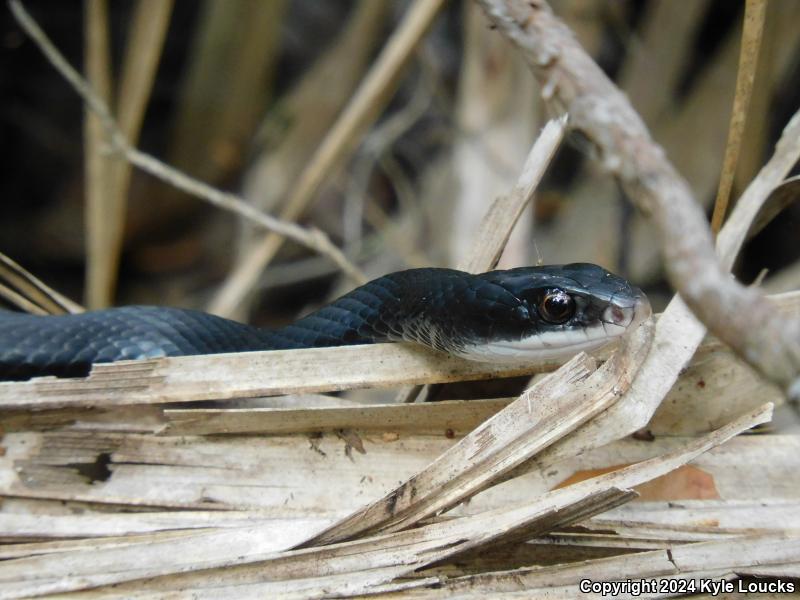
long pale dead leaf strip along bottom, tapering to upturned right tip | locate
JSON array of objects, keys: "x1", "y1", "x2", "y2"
[{"x1": 0, "y1": 406, "x2": 768, "y2": 598}]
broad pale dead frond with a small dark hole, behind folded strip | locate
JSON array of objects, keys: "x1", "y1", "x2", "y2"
[{"x1": 0, "y1": 432, "x2": 800, "y2": 524}]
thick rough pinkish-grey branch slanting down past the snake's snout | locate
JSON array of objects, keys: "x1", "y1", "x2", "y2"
[{"x1": 477, "y1": 0, "x2": 800, "y2": 396}]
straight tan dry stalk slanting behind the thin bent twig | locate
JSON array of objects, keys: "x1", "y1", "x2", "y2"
[{"x1": 210, "y1": 0, "x2": 444, "y2": 316}]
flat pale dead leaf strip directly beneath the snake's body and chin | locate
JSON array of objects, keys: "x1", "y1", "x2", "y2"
[{"x1": 0, "y1": 344, "x2": 557, "y2": 409}]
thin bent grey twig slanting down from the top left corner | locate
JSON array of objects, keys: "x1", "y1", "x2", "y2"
[{"x1": 9, "y1": 0, "x2": 366, "y2": 282}]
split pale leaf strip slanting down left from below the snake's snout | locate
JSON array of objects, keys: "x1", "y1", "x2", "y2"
[{"x1": 307, "y1": 325, "x2": 652, "y2": 545}]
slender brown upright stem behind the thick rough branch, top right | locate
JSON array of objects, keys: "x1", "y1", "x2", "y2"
[{"x1": 711, "y1": 0, "x2": 767, "y2": 234}]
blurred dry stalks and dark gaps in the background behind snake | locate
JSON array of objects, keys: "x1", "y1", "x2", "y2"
[{"x1": 0, "y1": 0, "x2": 800, "y2": 325}]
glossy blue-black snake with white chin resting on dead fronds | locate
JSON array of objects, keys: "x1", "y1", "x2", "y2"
[{"x1": 0, "y1": 263, "x2": 649, "y2": 380}]
